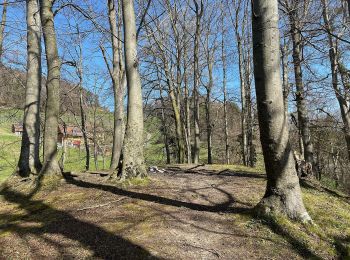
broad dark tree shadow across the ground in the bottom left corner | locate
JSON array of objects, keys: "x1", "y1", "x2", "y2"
[{"x1": 0, "y1": 186, "x2": 157, "y2": 259}]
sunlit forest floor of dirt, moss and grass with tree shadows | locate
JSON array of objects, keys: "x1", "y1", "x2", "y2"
[{"x1": 0, "y1": 166, "x2": 350, "y2": 259}]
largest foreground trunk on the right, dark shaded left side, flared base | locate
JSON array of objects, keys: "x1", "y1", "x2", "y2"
[{"x1": 252, "y1": 0, "x2": 311, "y2": 221}]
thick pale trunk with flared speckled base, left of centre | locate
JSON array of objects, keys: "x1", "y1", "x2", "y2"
[{"x1": 121, "y1": 0, "x2": 147, "y2": 179}]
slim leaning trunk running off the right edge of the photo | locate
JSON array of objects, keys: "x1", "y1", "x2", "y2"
[{"x1": 322, "y1": 0, "x2": 350, "y2": 160}]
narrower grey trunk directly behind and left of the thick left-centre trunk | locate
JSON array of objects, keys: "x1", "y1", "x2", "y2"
[{"x1": 106, "y1": 0, "x2": 125, "y2": 171}]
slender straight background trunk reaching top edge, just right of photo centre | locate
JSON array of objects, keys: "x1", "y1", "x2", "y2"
[{"x1": 193, "y1": 0, "x2": 204, "y2": 163}]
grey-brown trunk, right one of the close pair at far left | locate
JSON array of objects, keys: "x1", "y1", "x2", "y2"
[{"x1": 40, "y1": 0, "x2": 61, "y2": 175}]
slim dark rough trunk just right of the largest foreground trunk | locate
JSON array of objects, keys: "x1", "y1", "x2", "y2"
[{"x1": 289, "y1": 10, "x2": 314, "y2": 165}]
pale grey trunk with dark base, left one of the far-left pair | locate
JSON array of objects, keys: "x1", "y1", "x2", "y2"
[{"x1": 18, "y1": 0, "x2": 41, "y2": 177}]
